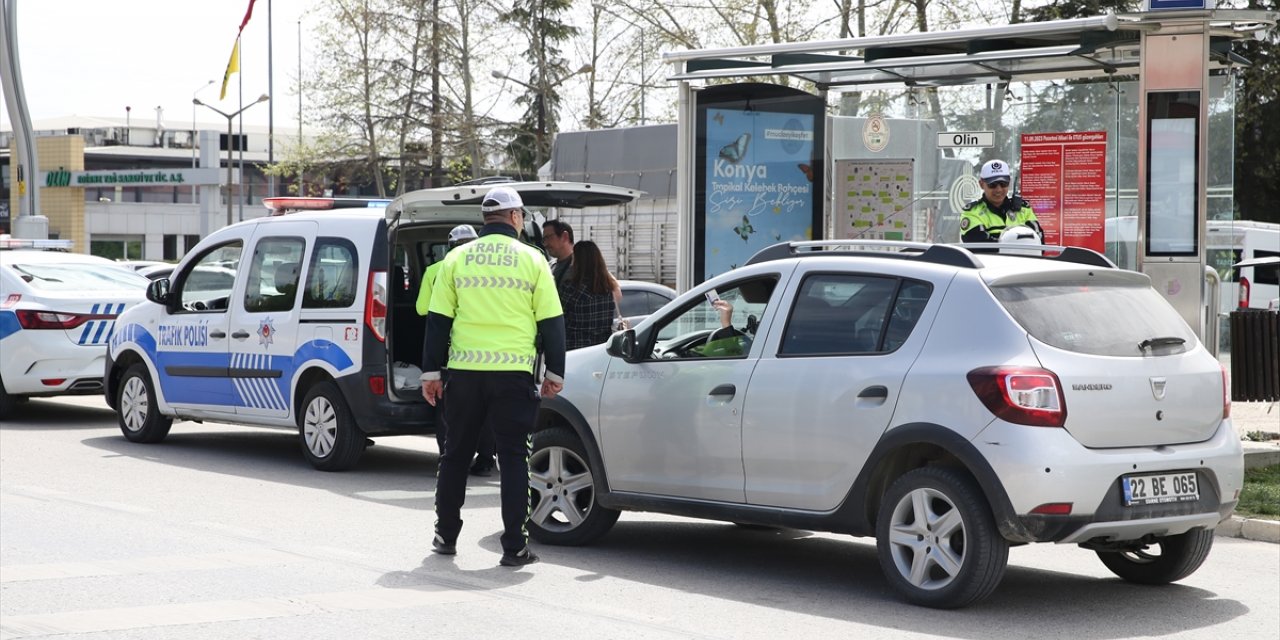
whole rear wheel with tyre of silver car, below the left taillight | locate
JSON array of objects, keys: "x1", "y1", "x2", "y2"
[{"x1": 876, "y1": 467, "x2": 1009, "y2": 609}]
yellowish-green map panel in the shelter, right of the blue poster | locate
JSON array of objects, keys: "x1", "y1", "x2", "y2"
[{"x1": 835, "y1": 160, "x2": 927, "y2": 241}]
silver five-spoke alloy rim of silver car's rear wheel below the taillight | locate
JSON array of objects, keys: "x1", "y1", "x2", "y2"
[{"x1": 890, "y1": 488, "x2": 965, "y2": 590}]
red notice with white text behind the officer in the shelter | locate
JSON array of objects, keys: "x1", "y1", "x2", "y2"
[{"x1": 1018, "y1": 131, "x2": 1107, "y2": 252}]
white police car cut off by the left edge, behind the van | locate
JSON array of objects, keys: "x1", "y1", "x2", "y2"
[{"x1": 0, "y1": 237, "x2": 148, "y2": 417}]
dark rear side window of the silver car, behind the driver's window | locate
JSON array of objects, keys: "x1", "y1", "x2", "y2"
[{"x1": 778, "y1": 274, "x2": 911, "y2": 356}]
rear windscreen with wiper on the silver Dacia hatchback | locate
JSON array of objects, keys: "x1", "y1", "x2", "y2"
[{"x1": 991, "y1": 283, "x2": 1196, "y2": 357}]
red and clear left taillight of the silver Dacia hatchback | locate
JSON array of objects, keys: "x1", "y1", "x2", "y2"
[{"x1": 968, "y1": 366, "x2": 1066, "y2": 426}]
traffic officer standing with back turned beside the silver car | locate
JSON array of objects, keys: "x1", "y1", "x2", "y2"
[{"x1": 422, "y1": 187, "x2": 564, "y2": 567}]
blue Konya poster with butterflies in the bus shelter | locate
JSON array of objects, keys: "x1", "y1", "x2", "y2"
[{"x1": 704, "y1": 109, "x2": 814, "y2": 278}]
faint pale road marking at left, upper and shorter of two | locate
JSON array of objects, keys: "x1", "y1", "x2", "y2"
[{"x1": 0, "y1": 549, "x2": 311, "y2": 584}]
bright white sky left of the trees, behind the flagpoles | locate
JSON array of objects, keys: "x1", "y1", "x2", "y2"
[{"x1": 0, "y1": 0, "x2": 316, "y2": 129}]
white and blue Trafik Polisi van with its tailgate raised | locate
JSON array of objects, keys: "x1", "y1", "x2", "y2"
[{"x1": 104, "y1": 180, "x2": 640, "y2": 471}]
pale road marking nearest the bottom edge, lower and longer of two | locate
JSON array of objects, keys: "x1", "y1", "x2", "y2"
[{"x1": 0, "y1": 589, "x2": 490, "y2": 640}]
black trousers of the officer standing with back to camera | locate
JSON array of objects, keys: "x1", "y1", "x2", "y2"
[{"x1": 435, "y1": 369, "x2": 539, "y2": 553}]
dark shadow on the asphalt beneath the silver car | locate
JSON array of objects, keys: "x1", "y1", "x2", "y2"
[{"x1": 509, "y1": 513, "x2": 1248, "y2": 640}]
